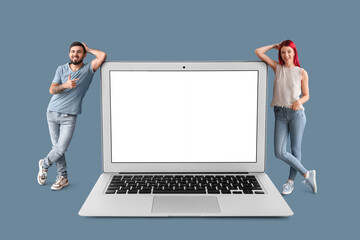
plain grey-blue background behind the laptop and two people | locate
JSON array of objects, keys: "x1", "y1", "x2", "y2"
[{"x1": 0, "y1": 0, "x2": 360, "y2": 239}]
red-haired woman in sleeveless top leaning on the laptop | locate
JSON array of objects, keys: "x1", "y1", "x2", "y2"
[{"x1": 255, "y1": 40, "x2": 317, "y2": 194}]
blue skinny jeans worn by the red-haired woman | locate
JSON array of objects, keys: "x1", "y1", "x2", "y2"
[{"x1": 274, "y1": 107, "x2": 307, "y2": 180}]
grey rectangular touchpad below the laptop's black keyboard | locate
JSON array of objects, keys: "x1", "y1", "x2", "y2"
[{"x1": 151, "y1": 196, "x2": 220, "y2": 213}]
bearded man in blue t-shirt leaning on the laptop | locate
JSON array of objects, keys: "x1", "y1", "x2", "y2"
[{"x1": 37, "y1": 42, "x2": 106, "y2": 190}]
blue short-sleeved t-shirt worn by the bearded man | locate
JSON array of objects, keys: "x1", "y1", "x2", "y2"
[{"x1": 47, "y1": 63, "x2": 94, "y2": 115}]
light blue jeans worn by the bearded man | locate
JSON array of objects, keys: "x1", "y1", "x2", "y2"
[{"x1": 43, "y1": 111, "x2": 77, "y2": 178}]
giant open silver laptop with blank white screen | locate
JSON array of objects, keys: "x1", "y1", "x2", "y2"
[{"x1": 79, "y1": 62, "x2": 293, "y2": 217}]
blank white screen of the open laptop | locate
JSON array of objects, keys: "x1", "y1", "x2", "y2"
[{"x1": 110, "y1": 71, "x2": 258, "y2": 162}]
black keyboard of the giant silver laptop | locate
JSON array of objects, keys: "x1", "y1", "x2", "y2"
[{"x1": 105, "y1": 175, "x2": 264, "y2": 194}]
